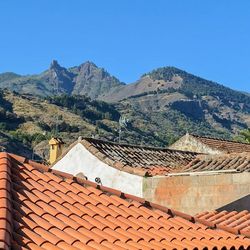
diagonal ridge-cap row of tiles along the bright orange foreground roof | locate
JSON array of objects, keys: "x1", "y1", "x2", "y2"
[{"x1": 5, "y1": 152, "x2": 249, "y2": 238}]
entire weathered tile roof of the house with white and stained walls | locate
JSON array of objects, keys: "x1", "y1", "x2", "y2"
[{"x1": 53, "y1": 138, "x2": 250, "y2": 176}]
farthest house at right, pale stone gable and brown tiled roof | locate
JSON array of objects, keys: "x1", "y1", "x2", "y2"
[{"x1": 169, "y1": 133, "x2": 250, "y2": 154}]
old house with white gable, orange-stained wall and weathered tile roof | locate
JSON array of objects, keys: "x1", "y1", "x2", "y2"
[{"x1": 52, "y1": 138, "x2": 250, "y2": 214}]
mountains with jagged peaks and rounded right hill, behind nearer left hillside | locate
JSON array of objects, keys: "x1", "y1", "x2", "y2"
[{"x1": 0, "y1": 60, "x2": 250, "y2": 151}]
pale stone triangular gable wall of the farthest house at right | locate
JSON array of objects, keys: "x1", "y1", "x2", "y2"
[{"x1": 169, "y1": 134, "x2": 222, "y2": 155}]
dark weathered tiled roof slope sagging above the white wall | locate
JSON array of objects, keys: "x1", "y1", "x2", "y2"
[{"x1": 81, "y1": 138, "x2": 197, "y2": 176}]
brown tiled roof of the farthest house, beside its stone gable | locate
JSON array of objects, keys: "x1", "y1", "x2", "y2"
[{"x1": 191, "y1": 135, "x2": 250, "y2": 153}]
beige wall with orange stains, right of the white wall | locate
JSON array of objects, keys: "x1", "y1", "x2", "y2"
[{"x1": 143, "y1": 172, "x2": 250, "y2": 215}]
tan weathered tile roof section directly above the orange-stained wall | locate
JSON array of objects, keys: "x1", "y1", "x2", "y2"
[{"x1": 183, "y1": 153, "x2": 250, "y2": 172}]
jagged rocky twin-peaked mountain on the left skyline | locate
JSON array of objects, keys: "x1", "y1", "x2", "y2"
[{"x1": 0, "y1": 60, "x2": 125, "y2": 99}]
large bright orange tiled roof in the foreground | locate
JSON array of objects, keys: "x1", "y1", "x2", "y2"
[{"x1": 0, "y1": 153, "x2": 250, "y2": 250}]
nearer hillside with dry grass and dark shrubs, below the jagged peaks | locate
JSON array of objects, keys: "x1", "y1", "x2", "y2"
[{"x1": 0, "y1": 91, "x2": 167, "y2": 159}]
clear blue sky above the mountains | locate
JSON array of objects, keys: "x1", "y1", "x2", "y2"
[{"x1": 0, "y1": 0, "x2": 250, "y2": 92}]
